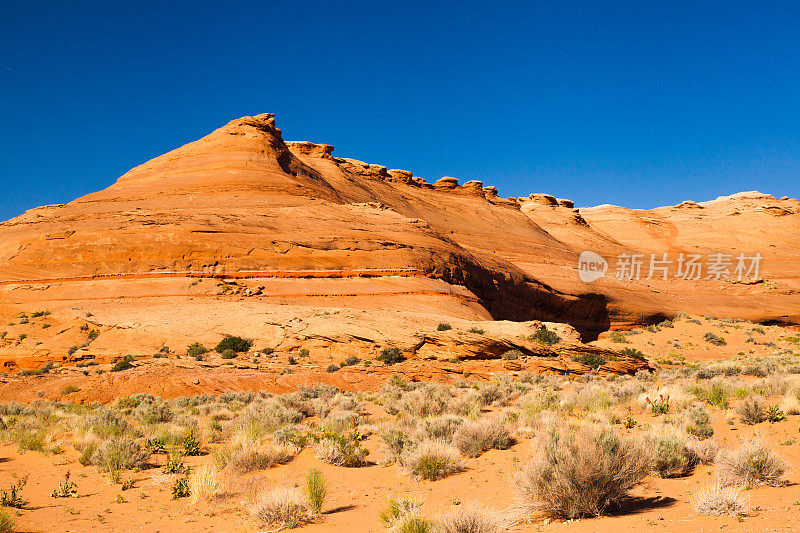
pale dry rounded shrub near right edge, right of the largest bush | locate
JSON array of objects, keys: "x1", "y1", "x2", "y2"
[{"x1": 716, "y1": 441, "x2": 787, "y2": 488}]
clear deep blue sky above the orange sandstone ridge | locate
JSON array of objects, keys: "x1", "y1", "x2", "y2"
[{"x1": 0, "y1": 0, "x2": 800, "y2": 220}]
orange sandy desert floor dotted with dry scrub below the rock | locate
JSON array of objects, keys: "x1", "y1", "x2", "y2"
[{"x1": 0, "y1": 315, "x2": 800, "y2": 532}]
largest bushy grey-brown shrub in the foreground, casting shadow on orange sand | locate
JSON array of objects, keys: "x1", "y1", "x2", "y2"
[{"x1": 516, "y1": 426, "x2": 651, "y2": 518}]
